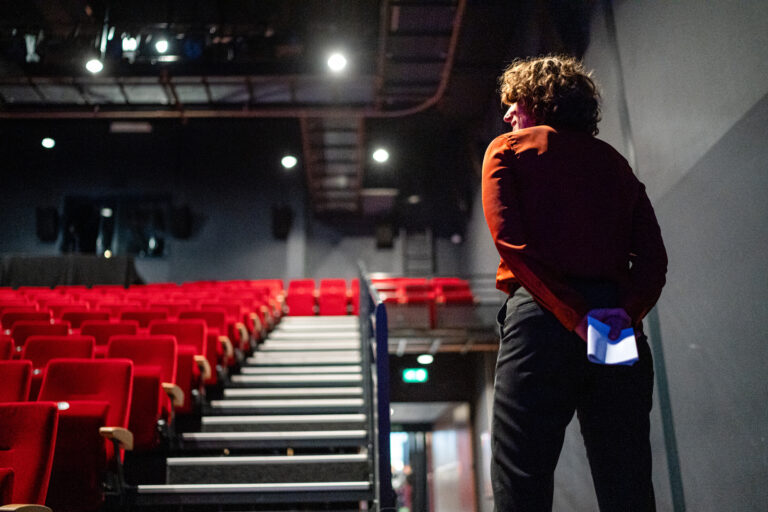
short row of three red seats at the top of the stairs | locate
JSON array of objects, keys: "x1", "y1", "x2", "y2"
[{"x1": 285, "y1": 279, "x2": 360, "y2": 316}]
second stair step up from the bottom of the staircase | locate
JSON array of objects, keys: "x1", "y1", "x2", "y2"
[{"x1": 167, "y1": 453, "x2": 368, "y2": 485}]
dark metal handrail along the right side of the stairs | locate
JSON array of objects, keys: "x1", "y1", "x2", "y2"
[{"x1": 358, "y1": 262, "x2": 395, "y2": 510}]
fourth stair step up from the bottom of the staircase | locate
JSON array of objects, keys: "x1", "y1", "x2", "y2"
[{"x1": 202, "y1": 414, "x2": 367, "y2": 432}]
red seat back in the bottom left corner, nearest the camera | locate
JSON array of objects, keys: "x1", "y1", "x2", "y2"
[{"x1": 0, "y1": 402, "x2": 58, "y2": 505}]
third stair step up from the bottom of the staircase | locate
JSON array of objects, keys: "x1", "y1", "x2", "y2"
[{"x1": 182, "y1": 429, "x2": 367, "y2": 449}]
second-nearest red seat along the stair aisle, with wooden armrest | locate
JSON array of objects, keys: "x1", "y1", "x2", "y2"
[{"x1": 38, "y1": 359, "x2": 133, "y2": 512}]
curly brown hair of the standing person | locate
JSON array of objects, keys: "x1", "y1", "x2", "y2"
[{"x1": 499, "y1": 55, "x2": 600, "y2": 135}]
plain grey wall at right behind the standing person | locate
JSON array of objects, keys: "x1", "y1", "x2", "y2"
[{"x1": 466, "y1": 0, "x2": 768, "y2": 512}]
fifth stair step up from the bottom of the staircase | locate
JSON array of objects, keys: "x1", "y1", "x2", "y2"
[{"x1": 210, "y1": 398, "x2": 364, "y2": 414}]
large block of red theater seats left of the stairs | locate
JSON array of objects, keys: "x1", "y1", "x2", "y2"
[{"x1": 0, "y1": 281, "x2": 290, "y2": 511}]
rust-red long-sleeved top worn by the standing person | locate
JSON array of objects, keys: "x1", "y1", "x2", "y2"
[{"x1": 483, "y1": 126, "x2": 667, "y2": 330}]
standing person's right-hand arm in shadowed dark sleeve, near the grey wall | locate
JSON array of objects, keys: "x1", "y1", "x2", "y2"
[{"x1": 620, "y1": 183, "x2": 667, "y2": 326}]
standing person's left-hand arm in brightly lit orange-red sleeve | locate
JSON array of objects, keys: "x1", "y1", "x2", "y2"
[{"x1": 482, "y1": 137, "x2": 589, "y2": 331}]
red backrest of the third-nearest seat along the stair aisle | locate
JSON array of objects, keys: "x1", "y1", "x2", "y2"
[{"x1": 107, "y1": 334, "x2": 177, "y2": 383}]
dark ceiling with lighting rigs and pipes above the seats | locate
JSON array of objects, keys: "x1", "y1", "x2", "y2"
[{"x1": 0, "y1": 0, "x2": 592, "y2": 222}]
